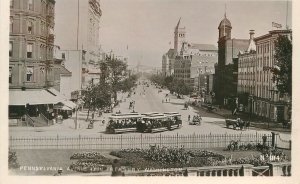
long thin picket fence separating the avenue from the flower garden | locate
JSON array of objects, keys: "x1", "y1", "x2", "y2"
[{"x1": 9, "y1": 133, "x2": 272, "y2": 149}]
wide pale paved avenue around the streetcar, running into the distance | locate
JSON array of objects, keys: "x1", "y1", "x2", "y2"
[{"x1": 9, "y1": 79, "x2": 290, "y2": 139}]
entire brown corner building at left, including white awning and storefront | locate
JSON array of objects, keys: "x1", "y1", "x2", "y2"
[{"x1": 9, "y1": 0, "x2": 72, "y2": 123}]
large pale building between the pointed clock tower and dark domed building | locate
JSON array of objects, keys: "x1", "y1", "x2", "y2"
[{"x1": 174, "y1": 42, "x2": 218, "y2": 93}]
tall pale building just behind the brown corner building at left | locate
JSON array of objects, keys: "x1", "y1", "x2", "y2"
[{"x1": 55, "y1": 0, "x2": 102, "y2": 88}]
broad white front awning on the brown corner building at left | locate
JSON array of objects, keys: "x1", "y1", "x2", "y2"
[{"x1": 9, "y1": 89, "x2": 60, "y2": 106}]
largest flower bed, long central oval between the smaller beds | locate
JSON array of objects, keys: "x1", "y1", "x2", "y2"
[{"x1": 110, "y1": 147, "x2": 227, "y2": 169}]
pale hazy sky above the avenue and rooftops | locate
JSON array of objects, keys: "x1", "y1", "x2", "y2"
[{"x1": 55, "y1": 0, "x2": 292, "y2": 67}]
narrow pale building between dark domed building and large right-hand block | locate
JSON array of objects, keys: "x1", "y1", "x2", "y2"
[{"x1": 237, "y1": 30, "x2": 256, "y2": 113}]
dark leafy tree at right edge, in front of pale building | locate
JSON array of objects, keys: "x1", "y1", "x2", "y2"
[{"x1": 271, "y1": 35, "x2": 293, "y2": 96}]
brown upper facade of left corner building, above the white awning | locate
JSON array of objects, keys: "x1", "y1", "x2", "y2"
[{"x1": 9, "y1": 0, "x2": 55, "y2": 89}]
